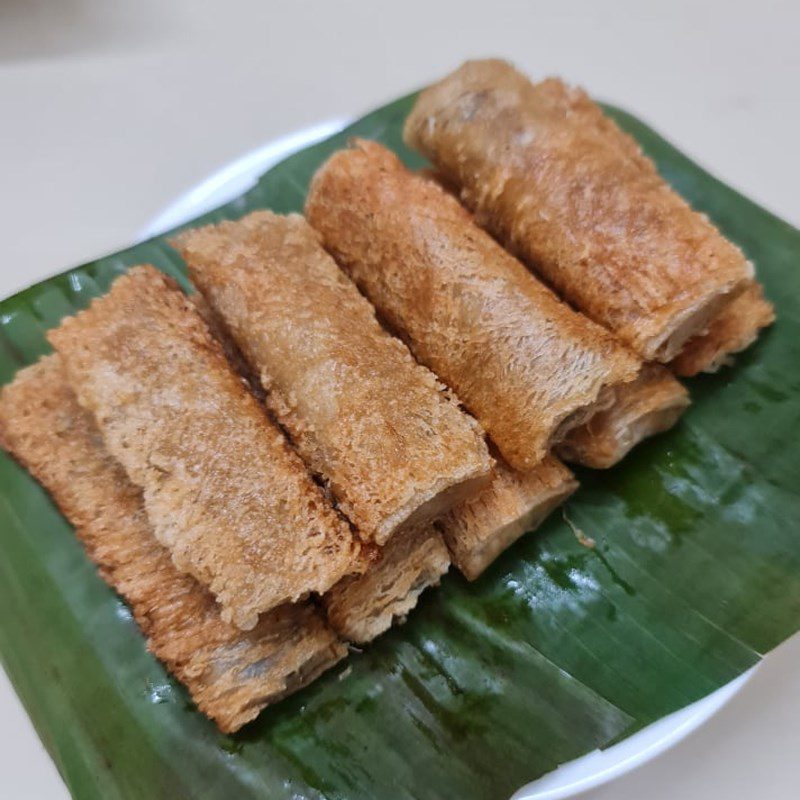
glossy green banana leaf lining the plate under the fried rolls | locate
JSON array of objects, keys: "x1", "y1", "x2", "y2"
[{"x1": 0, "y1": 97, "x2": 800, "y2": 800}]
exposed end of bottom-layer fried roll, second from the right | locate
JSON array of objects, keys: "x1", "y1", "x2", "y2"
[{"x1": 556, "y1": 364, "x2": 689, "y2": 469}]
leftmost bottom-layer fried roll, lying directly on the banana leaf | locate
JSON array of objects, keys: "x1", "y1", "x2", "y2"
[{"x1": 0, "y1": 355, "x2": 346, "y2": 733}]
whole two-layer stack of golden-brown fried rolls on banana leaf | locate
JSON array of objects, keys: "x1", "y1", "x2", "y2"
[{"x1": 0, "y1": 54, "x2": 774, "y2": 732}]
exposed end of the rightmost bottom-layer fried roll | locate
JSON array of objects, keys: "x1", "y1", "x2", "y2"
[{"x1": 670, "y1": 281, "x2": 775, "y2": 377}]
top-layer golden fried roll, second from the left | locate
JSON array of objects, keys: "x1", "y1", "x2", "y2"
[{"x1": 176, "y1": 211, "x2": 491, "y2": 544}]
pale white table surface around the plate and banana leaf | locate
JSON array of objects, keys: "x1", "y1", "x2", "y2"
[{"x1": 0, "y1": 0, "x2": 800, "y2": 800}]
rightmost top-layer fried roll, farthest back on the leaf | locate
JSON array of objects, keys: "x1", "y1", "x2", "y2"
[{"x1": 404, "y1": 60, "x2": 753, "y2": 362}]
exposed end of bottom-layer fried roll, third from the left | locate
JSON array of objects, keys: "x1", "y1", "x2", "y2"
[{"x1": 439, "y1": 456, "x2": 578, "y2": 581}]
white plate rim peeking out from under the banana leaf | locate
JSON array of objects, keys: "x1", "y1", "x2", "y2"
[{"x1": 140, "y1": 120, "x2": 758, "y2": 800}]
